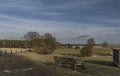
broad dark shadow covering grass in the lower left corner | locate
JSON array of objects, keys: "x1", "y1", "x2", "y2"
[{"x1": 0, "y1": 55, "x2": 62, "y2": 76}]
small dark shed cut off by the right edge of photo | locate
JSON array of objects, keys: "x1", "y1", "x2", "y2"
[{"x1": 113, "y1": 49, "x2": 120, "y2": 67}]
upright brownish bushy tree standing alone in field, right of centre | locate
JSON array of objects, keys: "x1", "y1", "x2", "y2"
[{"x1": 81, "y1": 38, "x2": 95, "y2": 57}]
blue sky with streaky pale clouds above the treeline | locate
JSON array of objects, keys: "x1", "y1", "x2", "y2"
[{"x1": 0, "y1": 0, "x2": 120, "y2": 44}]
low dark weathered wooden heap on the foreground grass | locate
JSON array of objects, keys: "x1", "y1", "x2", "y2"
[{"x1": 54, "y1": 56, "x2": 86, "y2": 71}]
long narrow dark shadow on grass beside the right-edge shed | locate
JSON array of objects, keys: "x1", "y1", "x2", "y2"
[{"x1": 85, "y1": 60, "x2": 114, "y2": 67}]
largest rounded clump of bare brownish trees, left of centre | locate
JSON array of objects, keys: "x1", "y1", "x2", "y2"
[{"x1": 24, "y1": 32, "x2": 57, "y2": 54}]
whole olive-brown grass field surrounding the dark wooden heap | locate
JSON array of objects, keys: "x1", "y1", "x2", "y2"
[{"x1": 0, "y1": 47, "x2": 120, "y2": 76}]
